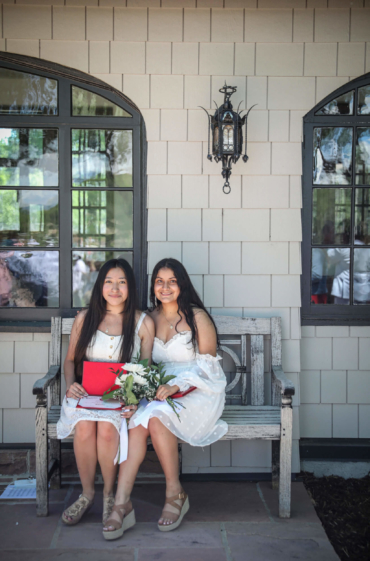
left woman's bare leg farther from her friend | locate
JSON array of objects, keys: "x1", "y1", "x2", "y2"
[{"x1": 66, "y1": 421, "x2": 97, "y2": 520}]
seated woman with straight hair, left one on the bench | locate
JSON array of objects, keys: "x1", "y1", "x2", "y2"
[{"x1": 57, "y1": 259, "x2": 154, "y2": 525}]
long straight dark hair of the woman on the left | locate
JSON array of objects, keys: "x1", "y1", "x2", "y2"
[{"x1": 74, "y1": 259, "x2": 139, "y2": 379}]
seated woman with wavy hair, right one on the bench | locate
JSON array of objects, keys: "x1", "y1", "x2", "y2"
[{"x1": 103, "y1": 259, "x2": 227, "y2": 540}]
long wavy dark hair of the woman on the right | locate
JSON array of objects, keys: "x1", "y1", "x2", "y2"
[{"x1": 150, "y1": 257, "x2": 220, "y2": 348}]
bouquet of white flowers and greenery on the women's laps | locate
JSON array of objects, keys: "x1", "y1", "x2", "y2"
[{"x1": 102, "y1": 359, "x2": 184, "y2": 420}]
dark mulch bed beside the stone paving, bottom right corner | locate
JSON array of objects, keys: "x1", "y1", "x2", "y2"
[{"x1": 303, "y1": 473, "x2": 370, "y2": 561}]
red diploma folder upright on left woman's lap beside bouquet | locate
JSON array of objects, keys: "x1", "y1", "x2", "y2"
[{"x1": 82, "y1": 361, "x2": 125, "y2": 395}]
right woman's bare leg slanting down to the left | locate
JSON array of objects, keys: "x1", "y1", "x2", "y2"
[{"x1": 104, "y1": 425, "x2": 149, "y2": 531}]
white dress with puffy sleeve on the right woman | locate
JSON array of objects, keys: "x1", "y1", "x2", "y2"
[{"x1": 129, "y1": 331, "x2": 228, "y2": 446}]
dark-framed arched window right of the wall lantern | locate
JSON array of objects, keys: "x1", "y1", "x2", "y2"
[{"x1": 302, "y1": 73, "x2": 370, "y2": 325}]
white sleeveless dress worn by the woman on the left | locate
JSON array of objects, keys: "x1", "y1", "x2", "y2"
[{"x1": 57, "y1": 312, "x2": 146, "y2": 439}]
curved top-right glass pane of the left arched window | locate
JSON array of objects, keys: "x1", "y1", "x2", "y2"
[{"x1": 72, "y1": 86, "x2": 132, "y2": 117}]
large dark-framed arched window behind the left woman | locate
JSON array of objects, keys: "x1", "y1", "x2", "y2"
[{"x1": 0, "y1": 53, "x2": 146, "y2": 321}]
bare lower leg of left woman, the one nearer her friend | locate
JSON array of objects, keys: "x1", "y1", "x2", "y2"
[{"x1": 97, "y1": 421, "x2": 119, "y2": 497}]
